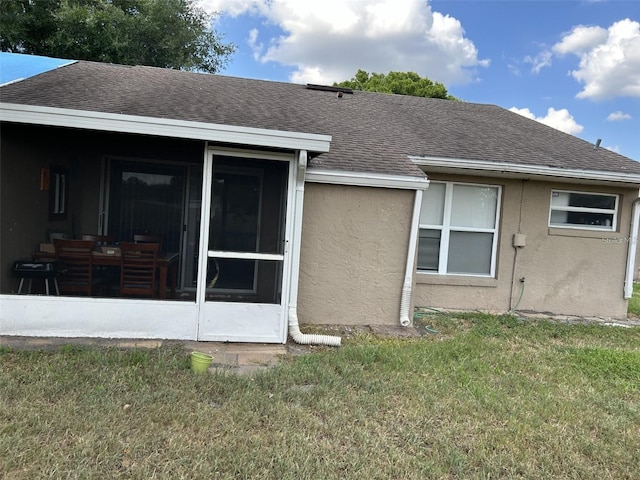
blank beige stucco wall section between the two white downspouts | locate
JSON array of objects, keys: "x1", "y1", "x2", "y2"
[{"x1": 298, "y1": 183, "x2": 415, "y2": 325}]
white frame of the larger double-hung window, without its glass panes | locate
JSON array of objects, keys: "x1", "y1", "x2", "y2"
[{"x1": 418, "y1": 180, "x2": 502, "y2": 278}]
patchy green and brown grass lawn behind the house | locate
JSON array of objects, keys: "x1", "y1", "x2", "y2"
[{"x1": 0, "y1": 313, "x2": 640, "y2": 480}]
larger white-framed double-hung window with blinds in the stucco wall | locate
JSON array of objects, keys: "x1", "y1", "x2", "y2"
[{"x1": 418, "y1": 182, "x2": 500, "y2": 276}]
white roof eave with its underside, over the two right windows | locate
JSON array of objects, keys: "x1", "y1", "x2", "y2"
[{"x1": 409, "y1": 156, "x2": 640, "y2": 188}]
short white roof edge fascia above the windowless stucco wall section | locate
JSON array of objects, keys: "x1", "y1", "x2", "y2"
[{"x1": 305, "y1": 168, "x2": 429, "y2": 190}]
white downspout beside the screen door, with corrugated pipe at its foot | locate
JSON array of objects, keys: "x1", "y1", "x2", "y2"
[{"x1": 289, "y1": 150, "x2": 342, "y2": 347}]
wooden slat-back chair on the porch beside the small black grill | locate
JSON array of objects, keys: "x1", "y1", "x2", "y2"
[{"x1": 53, "y1": 238, "x2": 95, "y2": 296}]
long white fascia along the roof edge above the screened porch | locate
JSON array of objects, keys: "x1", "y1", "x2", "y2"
[{"x1": 0, "y1": 103, "x2": 332, "y2": 153}]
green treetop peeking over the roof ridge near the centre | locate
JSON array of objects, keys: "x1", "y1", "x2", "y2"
[{"x1": 333, "y1": 70, "x2": 457, "y2": 100}]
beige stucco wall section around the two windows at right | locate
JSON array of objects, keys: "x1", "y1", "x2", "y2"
[{"x1": 415, "y1": 175, "x2": 638, "y2": 317}]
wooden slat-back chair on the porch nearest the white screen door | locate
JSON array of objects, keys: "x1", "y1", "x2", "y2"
[{"x1": 120, "y1": 242, "x2": 160, "y2": 298}]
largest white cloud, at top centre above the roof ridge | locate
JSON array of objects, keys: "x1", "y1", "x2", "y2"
[{"x1": 200, "y1": 0, "x2": 489, "y2": 86}]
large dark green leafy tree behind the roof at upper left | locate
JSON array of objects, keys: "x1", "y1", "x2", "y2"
[{"x1": 0, "y1": 0, "x2": 236, "y2": 73}]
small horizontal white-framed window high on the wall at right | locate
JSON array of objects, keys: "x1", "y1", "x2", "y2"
[{"x1": 549, "y1": 190, "x2": 618, "y2": 231}]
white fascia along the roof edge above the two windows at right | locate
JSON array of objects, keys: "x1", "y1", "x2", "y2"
[{"x1": 409, "y1": 155, "x2": 640, "y2": 185}]
